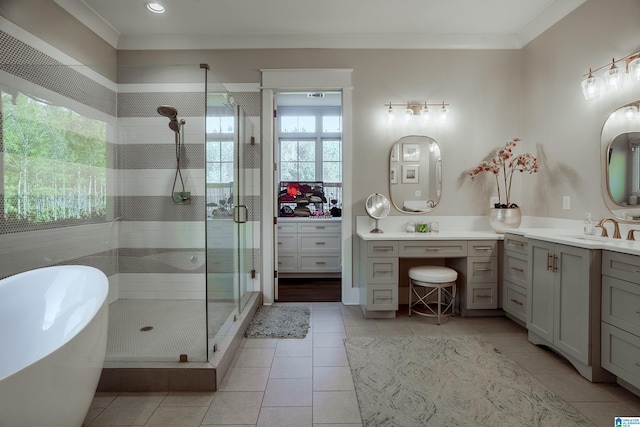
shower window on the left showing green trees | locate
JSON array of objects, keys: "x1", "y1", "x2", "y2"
[{"x1": 2, "y1": 90, "x2": 107, "y2": 230}]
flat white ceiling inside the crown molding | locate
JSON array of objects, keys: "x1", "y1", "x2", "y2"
[{"x1": 54, "y1": 0, "x2": 586, "y2": 50}]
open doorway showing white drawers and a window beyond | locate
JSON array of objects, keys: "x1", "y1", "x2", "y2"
[{"x1": 274, "y1": 91, "x2": 343, "y2": 302}]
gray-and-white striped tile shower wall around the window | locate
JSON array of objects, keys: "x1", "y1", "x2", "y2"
[{"x1": 0, "y1": 18, "x2": 261, "y2": 301}]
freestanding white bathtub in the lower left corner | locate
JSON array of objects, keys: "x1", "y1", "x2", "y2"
[{"x1": 0, "y1": 265, "x2": 109, "y2": 427}]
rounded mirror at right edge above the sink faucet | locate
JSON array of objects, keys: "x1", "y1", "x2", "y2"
[{"x1": 601, "y1": 101, "x2": 640, "y2": 222}]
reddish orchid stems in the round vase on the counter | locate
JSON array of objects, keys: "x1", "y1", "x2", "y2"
[{"x1": 469, "y1": 138, "x2": 538, "y2": 208}]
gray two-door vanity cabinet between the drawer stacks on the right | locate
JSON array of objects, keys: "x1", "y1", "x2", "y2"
[{"x1": 527, "y1": 239, "x2": 608, "y2": 381}]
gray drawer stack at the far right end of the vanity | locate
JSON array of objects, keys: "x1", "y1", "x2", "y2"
[{"x1": 602, "y1": 251, "x2": 640, "y2": 388}]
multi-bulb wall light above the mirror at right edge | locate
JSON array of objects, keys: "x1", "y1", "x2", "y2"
[{"x1": 581, "y1": 52, "x2": 640, "y2": 99}]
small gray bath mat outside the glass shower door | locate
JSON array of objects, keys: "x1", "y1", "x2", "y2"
[{"x1": 245, "y1": 305, "x2": 309, "y2": 338}]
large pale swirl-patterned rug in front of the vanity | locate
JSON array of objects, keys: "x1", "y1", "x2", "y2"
[{"x1": 345, "y1": 336, "x2": 593, "y2": 427}]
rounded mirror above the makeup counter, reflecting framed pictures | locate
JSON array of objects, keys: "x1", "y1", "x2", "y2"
[{"x1": 389, "y1": 135, "x2": 442, "y2": 214}]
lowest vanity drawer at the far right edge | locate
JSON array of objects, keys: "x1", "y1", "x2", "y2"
[{"x1": 601, "y1": 322, "x2": 640, "y2": 387}]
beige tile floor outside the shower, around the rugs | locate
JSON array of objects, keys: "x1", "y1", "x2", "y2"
[{"x1": 85, "y1": 303, "x2": 640, "y2": 427}]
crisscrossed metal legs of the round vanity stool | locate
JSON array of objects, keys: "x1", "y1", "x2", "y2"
[{"x1": 409, "y1": 279, "x2": 456, "y2": 325}]
